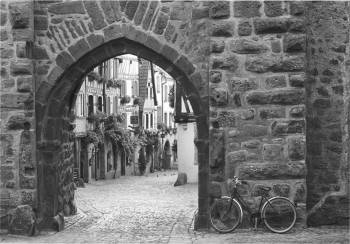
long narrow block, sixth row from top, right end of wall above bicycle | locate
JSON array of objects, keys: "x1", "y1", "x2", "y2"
[{"x1": 246, "y1": 89, "x2": 305, "y2": 105}]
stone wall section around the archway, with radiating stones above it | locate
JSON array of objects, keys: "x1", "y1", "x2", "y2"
[{"x1": 35, "y1": 1, "x2": 209, "y2": 228}]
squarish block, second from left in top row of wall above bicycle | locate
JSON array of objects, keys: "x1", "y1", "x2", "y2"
[{"x1": 233, "y1": 1, "x2": 261, "y2": 18}]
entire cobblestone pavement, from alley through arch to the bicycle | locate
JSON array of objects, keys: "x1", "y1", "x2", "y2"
[{"x1": 1, "y1": 171, "x2": 349, "y2": 243}]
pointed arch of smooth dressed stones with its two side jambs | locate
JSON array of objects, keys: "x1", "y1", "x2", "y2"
[{"x1": 36, "y1": 31, "x2": 209, "y2": 227}]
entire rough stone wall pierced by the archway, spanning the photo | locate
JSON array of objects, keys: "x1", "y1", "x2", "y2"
[{"x1": 0, "y1": 0, "x2": 350, "y2": 234}]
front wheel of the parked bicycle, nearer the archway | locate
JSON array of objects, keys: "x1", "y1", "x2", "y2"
[{"x1": 210, "y1": 196, "x2": 243, "y2": 233}]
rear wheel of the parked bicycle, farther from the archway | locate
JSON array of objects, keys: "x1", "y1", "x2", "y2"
[{"x1": 261, "y1": 197, "x2": 297, "y2": 234}]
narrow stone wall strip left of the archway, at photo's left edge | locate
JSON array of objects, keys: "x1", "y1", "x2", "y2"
[{"x1": 0, "y1": 1, "x2": 37, "y2": 234}]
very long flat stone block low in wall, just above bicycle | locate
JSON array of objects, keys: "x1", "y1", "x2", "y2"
[{"x1": 239, "y1": 162, "x2": 306, "y2": 180}]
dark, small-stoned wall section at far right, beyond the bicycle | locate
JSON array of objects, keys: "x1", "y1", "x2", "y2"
[{"x1": 306, "y1": 2, "x2": 350, "y2": 225}]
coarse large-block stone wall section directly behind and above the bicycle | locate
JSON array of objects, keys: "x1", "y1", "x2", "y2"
[{"x1": 209, "y1": 1, "x2": 306, "y2": 225}]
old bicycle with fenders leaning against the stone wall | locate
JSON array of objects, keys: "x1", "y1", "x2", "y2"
[{"x1": 210, "y1": 176, "x2": 296, "y2": 234}]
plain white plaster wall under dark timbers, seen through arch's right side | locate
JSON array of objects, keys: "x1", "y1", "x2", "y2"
[{"x1": 177, "y1": 123, "x2": 198, "y2": 183}]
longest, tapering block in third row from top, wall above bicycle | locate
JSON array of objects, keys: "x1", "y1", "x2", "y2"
[{"x1": 230, "y1": 38, "x2": 269, "y2": 54}]
